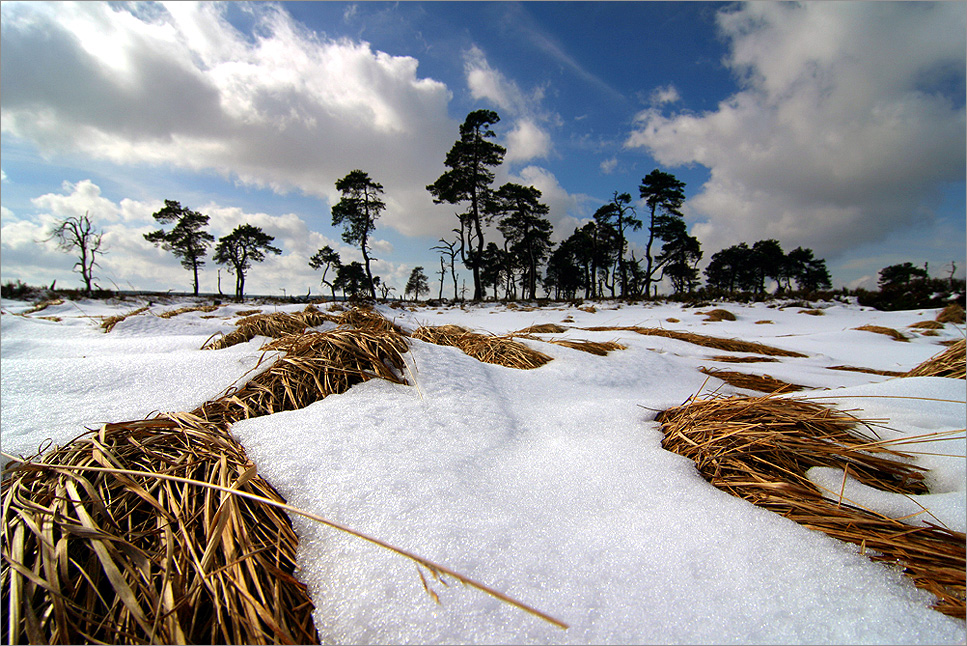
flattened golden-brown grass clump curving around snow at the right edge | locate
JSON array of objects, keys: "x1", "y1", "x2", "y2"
[{"x1": 658, "y1": 395, "x2": 965, "y2": 618}]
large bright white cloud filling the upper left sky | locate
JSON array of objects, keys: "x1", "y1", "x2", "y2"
[{"x1": 2, "y1": 3, "x2": 457, "y2": 240}]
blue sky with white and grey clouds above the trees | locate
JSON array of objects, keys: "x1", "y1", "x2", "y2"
[{"x1": 0, "y1": 2, "x2": 967, "y2": 297}]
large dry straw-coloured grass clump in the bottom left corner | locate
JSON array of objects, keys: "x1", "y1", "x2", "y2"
[{"x1": 2, "y1": 414, "x2": 319, "y2": 644}]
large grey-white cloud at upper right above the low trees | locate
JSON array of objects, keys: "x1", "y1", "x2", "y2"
[{"x1": 626, "y1": 2, "x2": 967, "y2": 256}]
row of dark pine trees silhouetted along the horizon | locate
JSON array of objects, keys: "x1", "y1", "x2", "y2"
[{"x1": 45, "y1": 110, "x2": 848, "y2": 301}]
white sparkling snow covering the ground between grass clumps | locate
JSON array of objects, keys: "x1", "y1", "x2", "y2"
[{"x1": 0, "y1": 301, "x2": 967, "y2": 644}]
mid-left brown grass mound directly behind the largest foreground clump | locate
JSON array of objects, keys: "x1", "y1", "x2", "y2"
[{"x1": 194, "y1": 329, "x2": 408, "y2": 423}]
